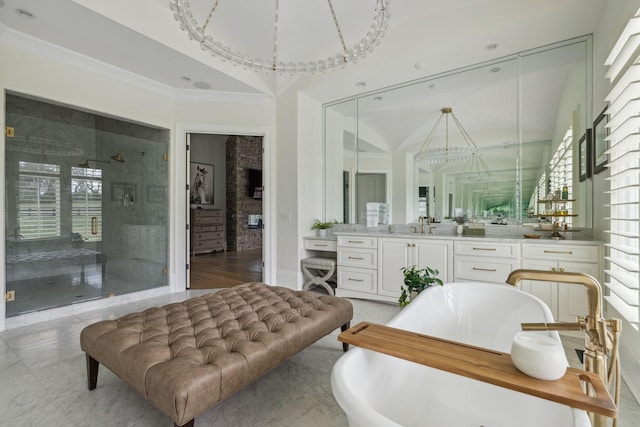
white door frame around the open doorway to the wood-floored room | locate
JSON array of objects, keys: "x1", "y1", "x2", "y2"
[{"x1": 169, "y1": 123, "x2": 276, "y2": 292}]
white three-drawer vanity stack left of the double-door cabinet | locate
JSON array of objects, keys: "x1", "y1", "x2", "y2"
[{"x1": 336, "y1": 236, "x2": 378, "y2": 299}]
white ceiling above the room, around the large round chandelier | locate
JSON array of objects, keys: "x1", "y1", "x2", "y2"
[{"x1": 0, "y1": 0, "x2": 605, "y2": 101}]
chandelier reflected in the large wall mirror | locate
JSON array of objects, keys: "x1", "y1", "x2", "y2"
[{"x1": 415, "y1": 107, "x2": 480, "y2": 163}]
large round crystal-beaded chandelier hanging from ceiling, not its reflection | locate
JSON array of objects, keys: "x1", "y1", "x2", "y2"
[{"x1": 170, "y1": 0, "x2": 389, "y2": 74}]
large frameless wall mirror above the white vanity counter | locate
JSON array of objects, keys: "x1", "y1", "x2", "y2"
[{"x1": 324, "y1": 36, "x2": 592, "y2": 228}]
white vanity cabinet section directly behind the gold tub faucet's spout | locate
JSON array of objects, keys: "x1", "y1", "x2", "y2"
[{"x1": 522, "y1": 242, "x2": 602, "y2": 322}]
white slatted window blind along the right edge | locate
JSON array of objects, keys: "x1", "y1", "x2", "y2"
[{"x1": 605, "y1": 11, "x2": 640, "y2": 330}]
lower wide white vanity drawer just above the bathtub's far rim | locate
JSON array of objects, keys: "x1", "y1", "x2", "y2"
[{"x1": 453, "y1": 255, "x2": 520, "y2": 283}]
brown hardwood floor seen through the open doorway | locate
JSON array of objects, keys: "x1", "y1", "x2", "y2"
[{"x1": 189, "y1": 249, "x2": 262, "y2": 289}]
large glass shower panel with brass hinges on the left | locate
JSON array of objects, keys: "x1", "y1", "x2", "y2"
[{"x1": 4, "y1": 93, "x2": 169, "y2": 317}]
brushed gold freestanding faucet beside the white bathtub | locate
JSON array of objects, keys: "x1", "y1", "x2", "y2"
[{"x1": 506, "y1": 269, "x2": 621, "y2": 427}]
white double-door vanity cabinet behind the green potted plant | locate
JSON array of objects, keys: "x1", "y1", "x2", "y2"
[{"x1": 378, "y1": 237, "x2": 453, "y2": 301}]
